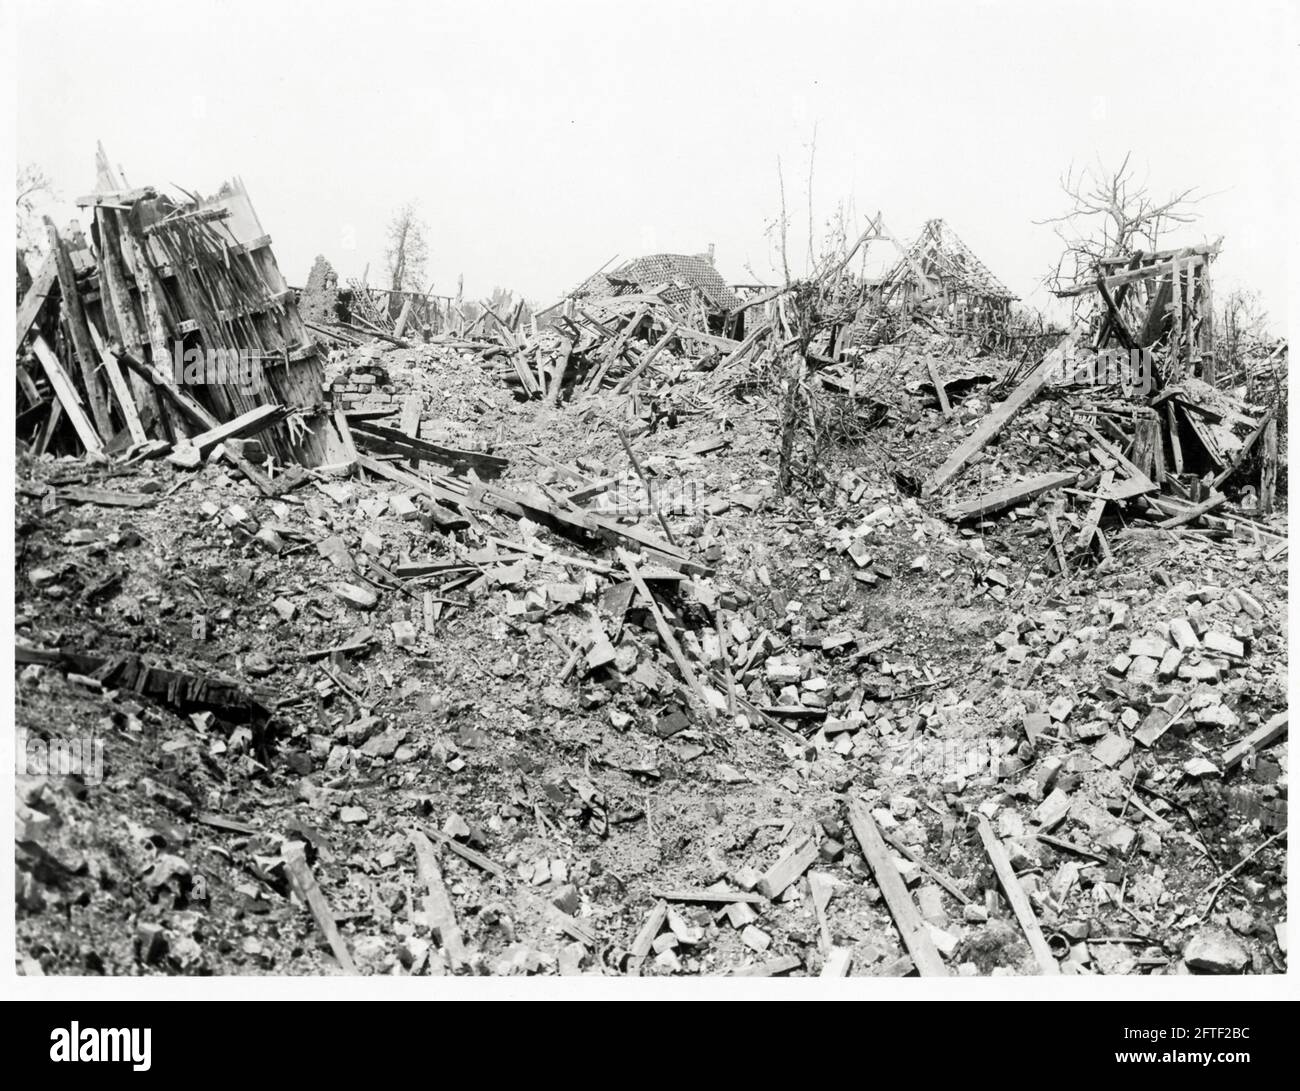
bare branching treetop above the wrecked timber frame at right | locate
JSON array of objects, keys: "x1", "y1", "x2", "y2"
[{"x1": 1035, "y1": 152, "x2": 1201, "y2": 290}]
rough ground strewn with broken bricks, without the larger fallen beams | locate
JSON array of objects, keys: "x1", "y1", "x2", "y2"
[{"x1": 16, "y1": 338, "x2": 1287, "y2": 975}]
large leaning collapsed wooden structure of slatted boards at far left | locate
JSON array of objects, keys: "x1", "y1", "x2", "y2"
[{"x1": 16, "y1": 148, "x2": 356, "y2": 484}]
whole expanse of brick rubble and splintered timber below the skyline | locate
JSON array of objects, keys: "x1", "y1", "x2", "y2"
[{"x1": 16, "y1": 166, "x2": 1288, "y2": 977}]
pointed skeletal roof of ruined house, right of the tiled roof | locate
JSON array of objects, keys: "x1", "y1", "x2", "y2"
[{"x1": 880, "y1": 220, "x2": 1017, "y2": 329}]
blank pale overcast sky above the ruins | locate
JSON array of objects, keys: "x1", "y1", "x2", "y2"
[{"x1": 16, "y1": 0, "x2": 1297, "y2": 320}]
